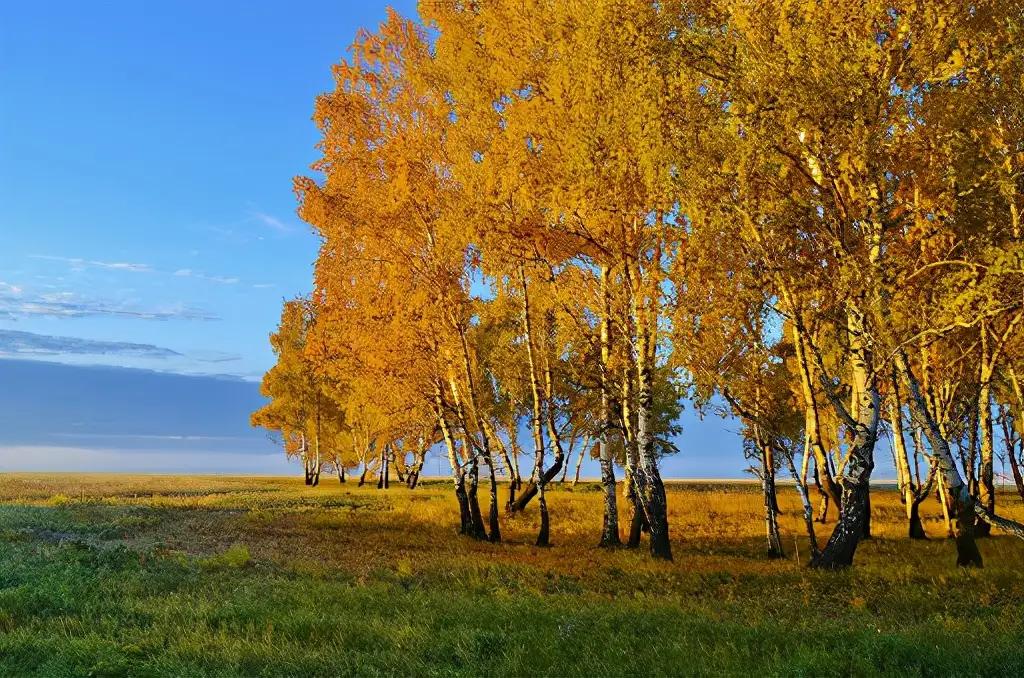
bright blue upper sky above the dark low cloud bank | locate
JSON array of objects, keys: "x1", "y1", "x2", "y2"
[{"x1": 0, "y1": 0, "x2": 415, "y2": 379}]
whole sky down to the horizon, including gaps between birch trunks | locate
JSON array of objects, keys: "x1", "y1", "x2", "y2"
[{"x1": 0, "y1": 0, "x2": 886, "y2": 477}]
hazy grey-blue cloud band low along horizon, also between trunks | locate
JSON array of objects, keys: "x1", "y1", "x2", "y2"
[{"x1": 0, "y1": 357, "x2": 895, "y2": 481}]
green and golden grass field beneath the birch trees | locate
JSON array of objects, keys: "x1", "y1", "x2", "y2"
[{"x1": 0, "y1": 474, "x2": 1024, "y2": 676}]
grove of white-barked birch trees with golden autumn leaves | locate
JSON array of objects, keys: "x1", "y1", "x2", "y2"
[{"x1": 253, "y1": 0, "x2": 1024, "y2": 568}]
